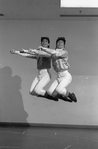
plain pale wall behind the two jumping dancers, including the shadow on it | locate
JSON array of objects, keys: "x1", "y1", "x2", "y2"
[{"x1": 0, "y1": 20, "x2": 98, "y2": 125}]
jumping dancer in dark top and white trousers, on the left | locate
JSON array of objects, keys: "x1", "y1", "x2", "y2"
[{"x1": 10, "y1": 37, "x2": 57, "y2": 100}]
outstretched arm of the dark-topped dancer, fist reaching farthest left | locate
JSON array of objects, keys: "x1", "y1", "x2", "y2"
[{"x1": 10, "y1": 49, "x2": 37, "y2": 59}]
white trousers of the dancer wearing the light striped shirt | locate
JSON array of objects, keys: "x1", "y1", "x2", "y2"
[{"x1": 48, "y1": 70, "x2": 72, "y2": 96}]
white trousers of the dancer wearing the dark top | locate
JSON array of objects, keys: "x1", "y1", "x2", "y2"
[{"x1": 30, "y1": 69, "x2": 51, "y2": 96}]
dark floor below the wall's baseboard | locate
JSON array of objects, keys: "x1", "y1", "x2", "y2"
[{"x1": 0, "y1": 127, "x2": 98, "y2": 149}]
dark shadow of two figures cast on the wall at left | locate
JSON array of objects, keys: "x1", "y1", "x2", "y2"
[{"x1": 0, "y1": 66, "x2": 28, "y2": 123}]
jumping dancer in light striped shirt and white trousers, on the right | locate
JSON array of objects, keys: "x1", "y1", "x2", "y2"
[{"x1": 29, "y1": 37, "x2": 77, "y2": 102}]
